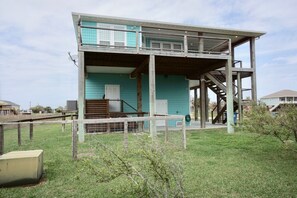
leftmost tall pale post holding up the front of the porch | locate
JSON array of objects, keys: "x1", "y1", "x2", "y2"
[{"x1": 78, "y1": 51, "x2": 85, "y2": 142}]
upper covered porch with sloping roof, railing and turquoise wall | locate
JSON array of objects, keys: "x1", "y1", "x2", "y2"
[{"x1": 72, "y1": 13, "x2": 263, "y2": 60}]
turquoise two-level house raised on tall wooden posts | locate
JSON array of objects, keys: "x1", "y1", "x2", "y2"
[{"x1": 72, "y1": 13, "x2": 264, "y2": 141}]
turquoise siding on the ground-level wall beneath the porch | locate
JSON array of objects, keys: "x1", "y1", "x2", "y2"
[{"x1": 86, "y1": 73, "x2": 190, "y2": 126}]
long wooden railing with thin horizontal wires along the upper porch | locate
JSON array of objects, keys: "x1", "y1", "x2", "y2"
[{"x1": 78, "y1": 24, "x2": 231, "y2": 56}]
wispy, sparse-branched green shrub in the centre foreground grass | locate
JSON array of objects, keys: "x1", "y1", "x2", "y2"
[{"x1": 81, "y1": 139, "x2": 184, "y2": 197}]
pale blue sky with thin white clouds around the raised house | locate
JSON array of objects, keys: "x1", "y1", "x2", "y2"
[{"x1": 0, "y1": 0, "x2": 297, "y2": 109}]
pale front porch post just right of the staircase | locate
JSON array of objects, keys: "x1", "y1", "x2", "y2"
[{"x1": 225, "y1": 58, "x2": 234, "y2": 133}]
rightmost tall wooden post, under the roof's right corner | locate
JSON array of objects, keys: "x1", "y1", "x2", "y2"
[{"x1": 250, "y1": 38, "x2": 257, "y2": 102}]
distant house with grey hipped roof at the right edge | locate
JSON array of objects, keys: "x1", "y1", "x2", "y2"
[{"x1": 260, "y1": 90, "x2": 297, "y2": 111}]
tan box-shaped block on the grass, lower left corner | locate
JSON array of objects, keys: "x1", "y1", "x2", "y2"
[{"x1": 0, "y1": 150, "x2": 43, "y2": 186}]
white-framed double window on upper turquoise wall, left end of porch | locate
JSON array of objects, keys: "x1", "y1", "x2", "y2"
[{"x1": 97, "y1": 23, "x2": 126, "y2": 47}]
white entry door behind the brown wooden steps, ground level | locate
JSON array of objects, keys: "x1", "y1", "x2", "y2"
[{"x1": 105, "y1": 85, "x2": 121, "y2": 112}]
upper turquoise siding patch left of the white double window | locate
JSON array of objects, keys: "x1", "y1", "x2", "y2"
[{"x1": 82, "y1": 21, "x2": 97, "y2": 44}]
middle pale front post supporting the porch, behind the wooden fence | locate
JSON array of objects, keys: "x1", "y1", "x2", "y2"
[{"x1": 149, "y1": 55, "x2": 157, "y2": 138}]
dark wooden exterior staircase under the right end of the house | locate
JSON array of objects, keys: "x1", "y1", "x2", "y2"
[{"x1": 205, "y1": 71, "x2": 238, "y2": 124}]
